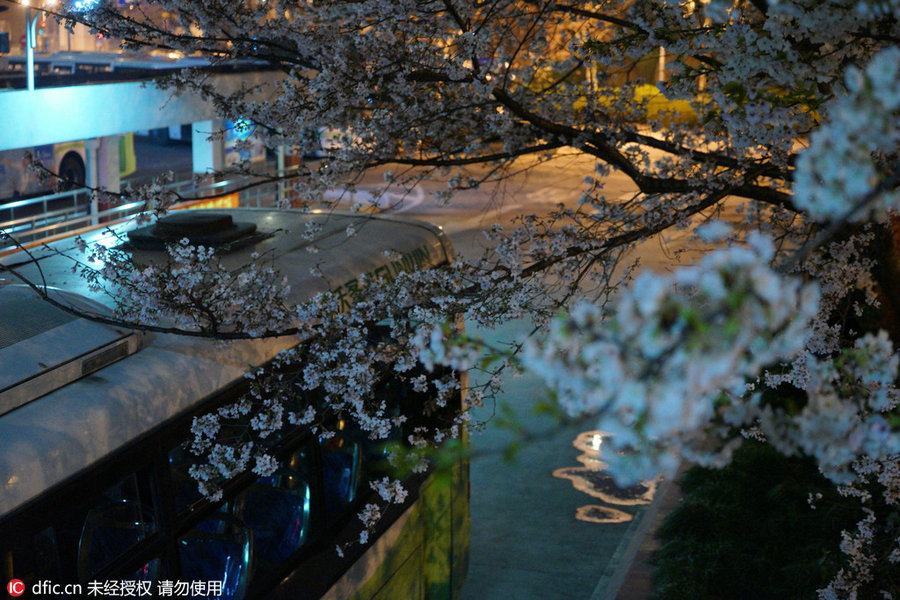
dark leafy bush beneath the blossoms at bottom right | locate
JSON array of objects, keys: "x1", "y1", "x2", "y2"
[{"x1": 654, "y1": 442, "x2": 859, "y2": 600}]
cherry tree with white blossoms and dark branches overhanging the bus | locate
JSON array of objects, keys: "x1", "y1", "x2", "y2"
[{"x1": 5, "y1": 0, "x2": 900, "y2": 598}]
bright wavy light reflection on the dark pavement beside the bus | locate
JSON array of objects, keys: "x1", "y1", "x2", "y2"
[{"x1": 553, "y1": 431, "x2": 660, "y2": 523}]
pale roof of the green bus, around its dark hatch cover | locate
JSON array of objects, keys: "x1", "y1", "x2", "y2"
[{"x1": 0, "y1": 209, "x2": 452, "y2": 516}]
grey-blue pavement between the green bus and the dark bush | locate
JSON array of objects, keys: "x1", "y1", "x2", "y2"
[{"x1": 461, "y1": 323, "x2": 678, "y2": 600}]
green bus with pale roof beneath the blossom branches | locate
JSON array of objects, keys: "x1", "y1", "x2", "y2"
[{"x1": 0, "y1": 209, "x2": 469, "y2": 600}]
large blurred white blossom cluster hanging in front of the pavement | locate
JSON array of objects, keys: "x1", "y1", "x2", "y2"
[{"x1": 523, "y1": 236, "x2": 819, "y2": 481}]
